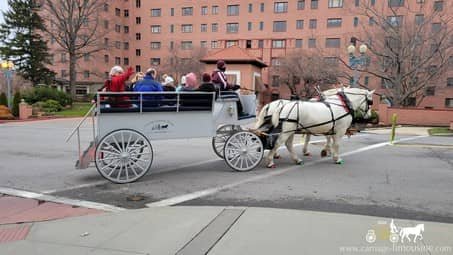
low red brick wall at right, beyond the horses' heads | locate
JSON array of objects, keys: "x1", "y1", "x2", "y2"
[{"x1": 379, "y1": 104, "x2": 453, "y2": 126}]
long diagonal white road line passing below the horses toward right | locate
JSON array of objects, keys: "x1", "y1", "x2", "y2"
[{"x1": 146, "y1": 136, "x2": 426, "y2": 207}]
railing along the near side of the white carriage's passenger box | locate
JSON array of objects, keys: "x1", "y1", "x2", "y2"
[{"x1": 97, "y1": 91, "x2": 215, "y2": 113}]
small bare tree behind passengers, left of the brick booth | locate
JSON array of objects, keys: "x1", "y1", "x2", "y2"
[{"x1": 161, "y1": 44, "x2": 207, "y2": 82}]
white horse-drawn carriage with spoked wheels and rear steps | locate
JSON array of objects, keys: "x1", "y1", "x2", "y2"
[{"x1": 67, "y1": 92, "x2": 264, "y2": 183}]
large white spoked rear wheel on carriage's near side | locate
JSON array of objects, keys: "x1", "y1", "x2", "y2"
[{"x1": 95, "y1": 129, "x2": 153, "y2": 183}]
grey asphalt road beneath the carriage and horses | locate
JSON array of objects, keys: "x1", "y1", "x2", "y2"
[{"x1": 0, "y1": 120, "x2": 453, "y2": 222}]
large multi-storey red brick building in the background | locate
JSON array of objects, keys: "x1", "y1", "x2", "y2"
[{"x1": 46, "y1": 0, "x2": 453, "y2": 108}]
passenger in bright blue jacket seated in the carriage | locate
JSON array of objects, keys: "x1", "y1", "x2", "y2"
[{"x1": 134, "y1": 68, "x2": 163, "y2": 106}]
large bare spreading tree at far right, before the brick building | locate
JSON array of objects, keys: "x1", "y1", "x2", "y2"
[{"x1": 359, "y1": 0, "x2": 453, "y2": 106}]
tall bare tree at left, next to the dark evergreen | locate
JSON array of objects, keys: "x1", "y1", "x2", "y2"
[{"x1": 42, "y1": 0, "x2": 108, "y2": 97}]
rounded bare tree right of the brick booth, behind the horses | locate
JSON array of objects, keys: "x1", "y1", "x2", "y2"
[{"x1": 271, "y1": 50, "x2": 342, "y2": 98}]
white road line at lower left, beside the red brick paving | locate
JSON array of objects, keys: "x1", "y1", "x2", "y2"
[{"x1": 0, "y1": 187, "x2": 126, "y2": 212}]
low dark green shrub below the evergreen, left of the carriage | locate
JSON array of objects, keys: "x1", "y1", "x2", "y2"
[{"x1": 23, "y1": 86, "x2": 72, "y2": 106}]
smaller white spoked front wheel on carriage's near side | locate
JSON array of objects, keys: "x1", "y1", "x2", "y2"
[{"x1": 224, "y1": 131, "x2": 264, "y2": 172}]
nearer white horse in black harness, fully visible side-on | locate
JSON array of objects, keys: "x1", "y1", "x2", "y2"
[{"x1": 267, "y1": 88, "x2": 374, "y2": 167}]
